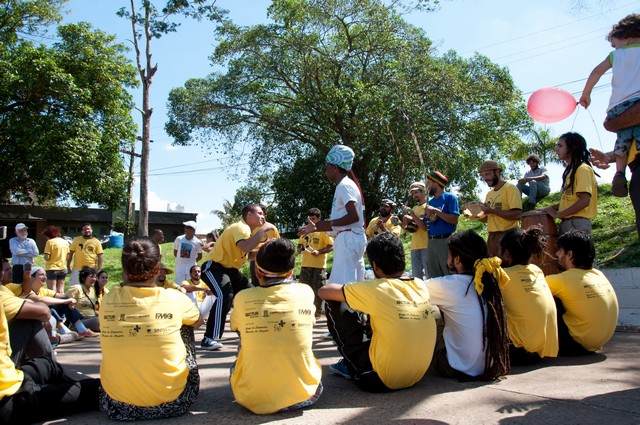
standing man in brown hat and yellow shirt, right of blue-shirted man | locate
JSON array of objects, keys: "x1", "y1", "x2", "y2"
[{"x1": 479, "y1": 160, "x2": 522, "y2": 257}]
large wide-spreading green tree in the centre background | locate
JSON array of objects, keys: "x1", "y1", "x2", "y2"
[{"x1": 166, "y1": 0, "x2": 530, "y2": 224}]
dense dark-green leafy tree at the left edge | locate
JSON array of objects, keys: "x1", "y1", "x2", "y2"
[{"x1": 0, "y1": 19, "x2": 136, "y2": 208}]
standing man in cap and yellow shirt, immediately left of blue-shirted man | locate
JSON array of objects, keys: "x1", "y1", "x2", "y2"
[{"x1": 402, "y1": 182, "x2": 429, "y2": 279}]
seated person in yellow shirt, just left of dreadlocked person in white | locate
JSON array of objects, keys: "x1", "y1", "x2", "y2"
[{"x1": 319, "y1": 233, "x2": 436, "y2": 392}]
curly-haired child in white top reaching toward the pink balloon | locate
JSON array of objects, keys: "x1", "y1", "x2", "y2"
[{"x1": 579, "y1": 14, "x2": 640, "y2": 197}]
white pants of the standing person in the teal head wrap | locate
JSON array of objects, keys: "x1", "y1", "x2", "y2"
[{"x1": 329, "y1": 232, "x2": 367, "y2": 284}]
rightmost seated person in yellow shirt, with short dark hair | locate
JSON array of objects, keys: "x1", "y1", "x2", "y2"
[{"x1": 547, "y1": 230, "x2": 618, "y2": 356}]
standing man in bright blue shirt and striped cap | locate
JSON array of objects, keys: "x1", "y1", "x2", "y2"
[{"x1": 424, "y1": 171, "x2": 460, "y2": 278}]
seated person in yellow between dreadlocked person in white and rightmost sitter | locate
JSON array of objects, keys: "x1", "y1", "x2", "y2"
[{"x1": 500, "y1": 227, "x2": 558, "y2": 365}]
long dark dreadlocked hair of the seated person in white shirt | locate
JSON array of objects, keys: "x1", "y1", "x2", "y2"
[{"x1": 449, "y1": 230, "x2": 511, "y2": 381}]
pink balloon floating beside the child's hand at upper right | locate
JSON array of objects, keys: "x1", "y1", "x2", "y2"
[{"x1": 527, "y1": 87, "x2": 578, "y2": 124}]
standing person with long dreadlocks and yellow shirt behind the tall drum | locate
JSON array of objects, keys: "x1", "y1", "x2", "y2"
[{"x1": 545, "y1": 132, "x2": 598, "y2": 235}]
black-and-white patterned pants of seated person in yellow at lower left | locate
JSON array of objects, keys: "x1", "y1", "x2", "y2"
[{"x1": 99, "y1": 326, "x2": 200, "y2": 421}]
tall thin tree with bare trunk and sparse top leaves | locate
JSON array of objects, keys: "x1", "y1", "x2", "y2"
[{"x1": 117, "y1": 0, "x2": 223, "y2": 236}]
